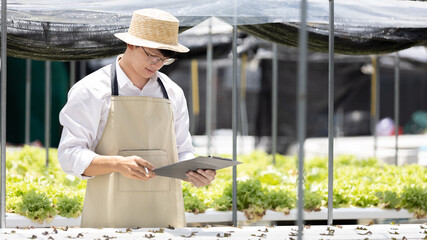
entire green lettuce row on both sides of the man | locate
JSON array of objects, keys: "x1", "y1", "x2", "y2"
[{"x1": 6, "y1": 146, "x2": 427, "y2": 223}]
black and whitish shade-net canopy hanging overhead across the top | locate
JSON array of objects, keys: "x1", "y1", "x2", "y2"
[{"x1": 2, "y1": 0, "x2": 427, "y2": 61}]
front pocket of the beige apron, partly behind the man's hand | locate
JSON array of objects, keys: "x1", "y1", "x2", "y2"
[{"x1": 118, "y1": 149, "x2": 171, "y2": 192}]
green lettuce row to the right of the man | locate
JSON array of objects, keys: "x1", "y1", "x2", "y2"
[{"x1": 183, "y1": 152, "x2": 427, "y2": 220}]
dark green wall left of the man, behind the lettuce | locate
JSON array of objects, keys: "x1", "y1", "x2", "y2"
[{"x1": 6, "y1": 57, "x2": 69, "y2": 147}]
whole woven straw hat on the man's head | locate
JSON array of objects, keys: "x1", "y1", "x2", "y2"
[{"x1": 114, "y1": 8, "x2": 190, "y2": 53}]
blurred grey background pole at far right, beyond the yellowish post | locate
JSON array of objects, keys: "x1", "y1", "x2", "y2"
[{"x1": 394, "y1": 52, "x2": 400, "y2": 166}]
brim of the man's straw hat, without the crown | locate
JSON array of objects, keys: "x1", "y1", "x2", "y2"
[{"x1": 114, "y1": 32, "x2": 190, "y2": 53}]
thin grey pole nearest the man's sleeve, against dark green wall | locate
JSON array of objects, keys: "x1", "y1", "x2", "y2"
[{"x1": 44, "y1": 61, "x2": 52, "y2": 167}]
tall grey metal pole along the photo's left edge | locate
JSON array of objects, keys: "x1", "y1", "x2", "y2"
[{"x1": 0, "y1": 0, "x2": 7, "y2": 229}]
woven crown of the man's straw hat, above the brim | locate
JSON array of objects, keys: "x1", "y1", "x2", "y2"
[{"x1": 128, "y1": 14, "x2": 179, "y2": 45}]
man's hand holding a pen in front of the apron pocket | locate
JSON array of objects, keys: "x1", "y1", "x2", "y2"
[{"x1": 117, "y1": 156, "x2": 156, "y2": 181}]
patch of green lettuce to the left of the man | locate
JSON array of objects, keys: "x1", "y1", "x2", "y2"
[{"x1": 6, "y1": 146, "x2": 86, "y2": 223}]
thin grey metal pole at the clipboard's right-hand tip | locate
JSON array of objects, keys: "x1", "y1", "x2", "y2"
[{"x1": 232, "y1": 25, "x2": 238, "y2": 229}]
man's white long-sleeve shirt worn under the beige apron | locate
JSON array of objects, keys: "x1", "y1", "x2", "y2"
[{"x1": 58, "y1": 60, "x2": 194, "y2": 179}]
